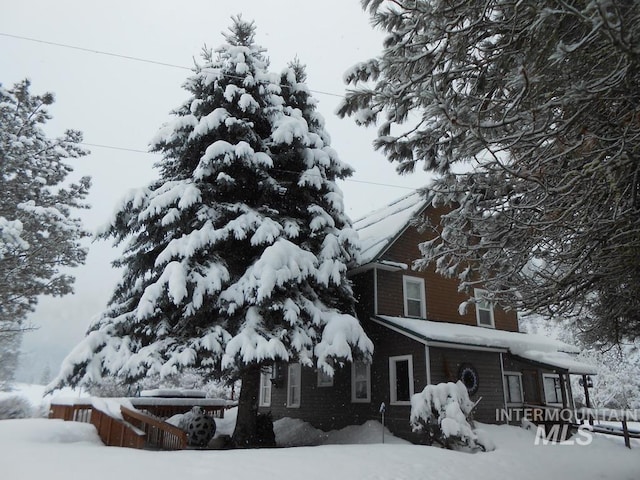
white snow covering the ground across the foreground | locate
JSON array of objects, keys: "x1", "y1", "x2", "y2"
[{"x1": 0, "y1": 389, "x2": 640, "y2": 480}]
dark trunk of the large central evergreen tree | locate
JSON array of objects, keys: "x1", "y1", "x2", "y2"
[{"x1": 232, "y1": 365, "x2": 260, "y2": 448}]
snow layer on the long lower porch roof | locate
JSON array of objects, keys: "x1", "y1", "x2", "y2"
[{"x1": 373, "y1": 315, "x2": 596, "y2": 375}]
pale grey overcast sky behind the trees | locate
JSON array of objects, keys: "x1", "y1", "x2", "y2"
[{"x1": 0, "y1": 0, "x2": 425, "y2": 381}]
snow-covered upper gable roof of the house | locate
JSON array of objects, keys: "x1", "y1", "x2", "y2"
[{"x1": 353, "y1": 191, "x2": 428, "y2": 265}]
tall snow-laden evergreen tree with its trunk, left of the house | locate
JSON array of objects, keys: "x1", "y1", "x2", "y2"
[{"x1": 54, "y1": 17, "x2": 373, "y2": 446}]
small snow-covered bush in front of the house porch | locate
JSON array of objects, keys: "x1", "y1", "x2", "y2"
[{"x1": 410, "y1": 380, "x2": 485, "y2": 450}]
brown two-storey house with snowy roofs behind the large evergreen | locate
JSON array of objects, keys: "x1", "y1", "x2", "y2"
[{"x1": 259, "y1": 192, "x2": 595, "y2": 441}]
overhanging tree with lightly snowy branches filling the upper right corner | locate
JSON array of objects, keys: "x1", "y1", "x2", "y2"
[{"x1": 340, "y1": 0, "x2": 640, "y2": 342}]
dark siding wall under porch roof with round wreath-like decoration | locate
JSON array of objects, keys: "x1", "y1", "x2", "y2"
[{"x1": 429, "y1": 347, "x2": 504, "y2": 423}]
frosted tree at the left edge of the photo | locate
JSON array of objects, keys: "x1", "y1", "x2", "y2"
[{"x1": 0, "y1": 80, "x2": 90, "y2": 334}]
